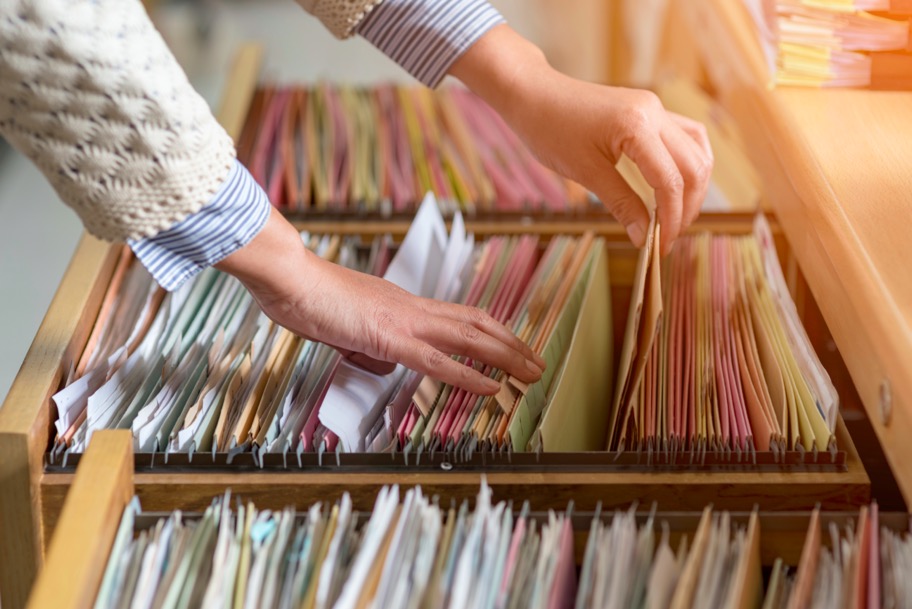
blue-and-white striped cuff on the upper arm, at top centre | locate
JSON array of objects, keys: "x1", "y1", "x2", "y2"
[{"x1": 357, "y1": 0, "x2": 505, "y2": 87}]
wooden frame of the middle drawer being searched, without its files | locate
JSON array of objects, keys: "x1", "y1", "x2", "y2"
[{"x1": 0, "y1": 41, "x2": 884, "y2": 607}]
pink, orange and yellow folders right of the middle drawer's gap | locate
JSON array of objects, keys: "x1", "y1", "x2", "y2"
[{"x1": 608, "y1": 216, "x2": 839, "y2": 457}]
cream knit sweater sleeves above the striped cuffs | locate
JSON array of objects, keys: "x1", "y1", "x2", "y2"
[{"x1": 0, "y1": 0, "x2": 377, "y2": 240}]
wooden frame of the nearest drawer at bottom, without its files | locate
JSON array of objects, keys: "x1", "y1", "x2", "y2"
[{"x1": 28, "y1": 431, "x2": 910, "y2": 609}]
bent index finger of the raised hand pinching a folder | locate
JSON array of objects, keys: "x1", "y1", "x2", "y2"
[{"x1": 624, "y1": 133, "x2": 684, "y2": 249}]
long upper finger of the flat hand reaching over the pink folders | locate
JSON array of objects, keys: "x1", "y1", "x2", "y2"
[{"x1": 415, "y1": 318, "x2": 542, "y2": 383}]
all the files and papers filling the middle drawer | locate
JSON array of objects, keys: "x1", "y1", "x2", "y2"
[{"x1": 53, "y1": 185, "x2": 838, "y2": 466}]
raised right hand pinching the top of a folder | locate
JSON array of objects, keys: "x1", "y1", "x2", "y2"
[{"x1": 450, "y1": 25, "x2": 713, "y2": 254}]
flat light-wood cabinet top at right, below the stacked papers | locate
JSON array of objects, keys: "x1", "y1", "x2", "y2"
[{"x1": 774, "y1": 88, "x2": 912, "y2": 334}]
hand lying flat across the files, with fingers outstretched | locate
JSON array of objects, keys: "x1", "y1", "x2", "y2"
[{"x1": 216, "y1": 209, "x2": 545, "y2": 395}]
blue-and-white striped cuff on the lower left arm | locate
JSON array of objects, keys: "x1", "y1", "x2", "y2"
[{"x1": 128, "y1": 161, "x2": 271, "y2": 291}]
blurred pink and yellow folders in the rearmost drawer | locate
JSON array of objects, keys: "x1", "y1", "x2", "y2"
[{"x1": 238, "y1": 83, "x2": 602, "y2": 215}]
